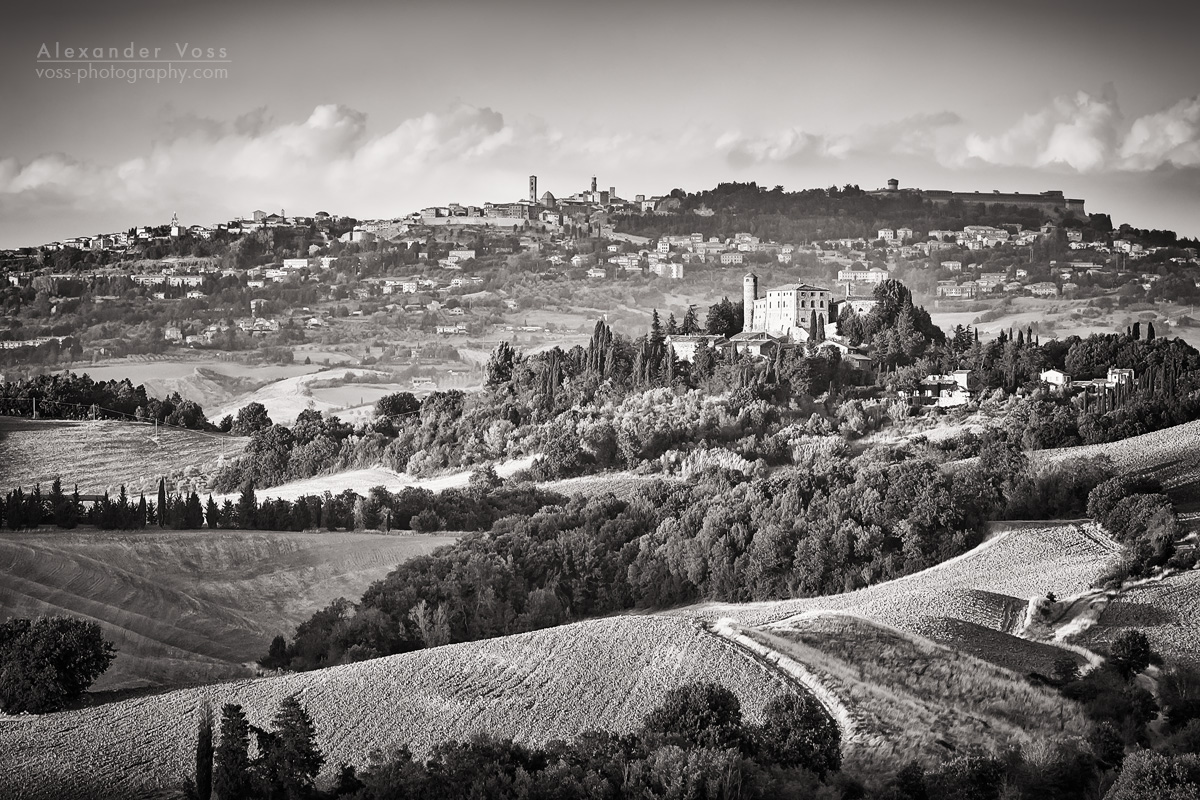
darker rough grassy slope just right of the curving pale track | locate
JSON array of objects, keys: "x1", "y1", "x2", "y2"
[{"x1": 724, "y1": 613, "x2": 1087, "y2": 772}]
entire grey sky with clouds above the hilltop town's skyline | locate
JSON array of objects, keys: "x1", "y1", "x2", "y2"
[{"x1": 0, "y1": 0, "x2": 1200, "y2": 247}]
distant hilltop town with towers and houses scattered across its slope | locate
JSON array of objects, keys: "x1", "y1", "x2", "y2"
[{"x1": 0, "y1": 176, "x2": 1200, "y2": 379}]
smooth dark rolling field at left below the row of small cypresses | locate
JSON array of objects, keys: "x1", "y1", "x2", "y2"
[{"x1": 0, "y1": 530, "x2": 454, "y2": 690}]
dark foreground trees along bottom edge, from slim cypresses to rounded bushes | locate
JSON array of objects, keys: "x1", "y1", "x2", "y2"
[{"x1": 186, "y1": 682, "x2": 841, "y2": 800}]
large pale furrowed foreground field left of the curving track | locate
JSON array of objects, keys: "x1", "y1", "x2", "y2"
[{"x1": 0, "y1": 616, "x2": 794, "y2": 799}]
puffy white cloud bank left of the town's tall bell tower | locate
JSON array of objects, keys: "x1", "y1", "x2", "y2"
[{"x1": 0, "y1": 104, "x2": 547, "y2": 232}]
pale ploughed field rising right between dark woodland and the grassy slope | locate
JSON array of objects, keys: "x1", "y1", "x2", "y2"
[{"x1": 686, "y1": 522, "x2": 1117, "y2": 674}]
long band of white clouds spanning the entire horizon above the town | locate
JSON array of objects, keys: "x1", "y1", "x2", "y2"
[{"x1": 0, "y1": 88, "x2": 1200, "y2": 243}]
